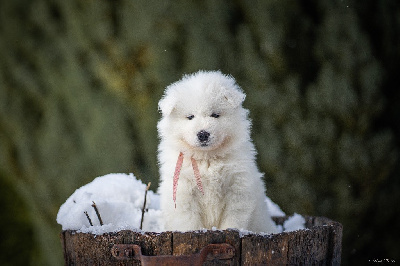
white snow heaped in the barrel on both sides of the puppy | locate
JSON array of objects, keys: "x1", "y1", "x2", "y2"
[{"x1": 57, "y1": 174, "x2": 305, "y2": 236}]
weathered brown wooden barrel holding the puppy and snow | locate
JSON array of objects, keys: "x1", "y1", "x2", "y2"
[{"x1": 61, "y1": 216, "x2": 342, "y2": 265}]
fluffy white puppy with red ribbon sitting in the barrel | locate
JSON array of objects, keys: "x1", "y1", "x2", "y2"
[{"x1": 158, "y1": 71, "x2": 277, "y2": 233}]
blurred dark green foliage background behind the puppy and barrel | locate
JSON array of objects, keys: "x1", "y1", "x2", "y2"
[{"x1": 0, "y1": 0, "x2": 400, "y2": 265}]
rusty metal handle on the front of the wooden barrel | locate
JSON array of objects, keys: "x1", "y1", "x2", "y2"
[{"x1": 111, "y1": 243, "x2": 235, "y2": 266}]
